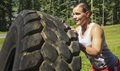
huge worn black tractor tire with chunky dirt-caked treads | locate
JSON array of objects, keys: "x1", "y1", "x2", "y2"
[{"x1": 0, "y1": 10, "x2": 81, "y2": 71}]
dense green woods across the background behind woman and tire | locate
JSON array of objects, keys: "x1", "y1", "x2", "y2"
[{"x1": 0, "y1": 0, "x2": 120, "y2": 31}]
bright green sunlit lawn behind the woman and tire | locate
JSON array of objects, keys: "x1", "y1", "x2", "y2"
[{"x1": 0, "y1": 25, "x2": 120, "y2": 71}]
